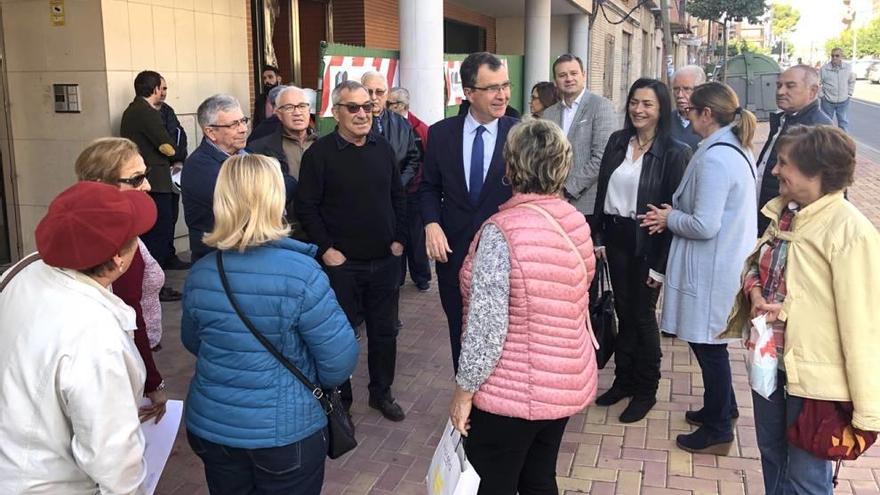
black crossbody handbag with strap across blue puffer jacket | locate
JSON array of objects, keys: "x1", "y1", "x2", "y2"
[{"x1": 217, "y1": 251, "x2": 357, "y2": 459}]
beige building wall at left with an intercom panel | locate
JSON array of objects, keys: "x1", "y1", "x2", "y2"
[{"x1": 0, "y1": 0, "x2": 250, "y2": 258}]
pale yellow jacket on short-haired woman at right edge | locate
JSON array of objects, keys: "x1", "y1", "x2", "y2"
[{"x1": 720, "y1": 192, "x2": 880, "y2": 431}]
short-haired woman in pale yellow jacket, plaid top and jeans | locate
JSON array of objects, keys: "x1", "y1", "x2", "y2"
[{"x1": 720, "y1": 125, "x2": 880, "y2": 495}]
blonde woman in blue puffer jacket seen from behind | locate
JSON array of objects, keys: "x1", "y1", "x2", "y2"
[{"x1": 181, "y1": 155, "x2": 358, "y2": 495}]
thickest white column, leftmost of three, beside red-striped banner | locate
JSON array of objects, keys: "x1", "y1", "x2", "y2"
[{"x1": 398, "y1": 0, "x2": 444, "y2": 125}]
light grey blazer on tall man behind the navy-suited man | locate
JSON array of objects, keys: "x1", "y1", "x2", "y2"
[{"x1": 543, "y1": 91, "x2": 620, "y2": 215}]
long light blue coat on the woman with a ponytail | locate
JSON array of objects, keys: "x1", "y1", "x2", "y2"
[{"x1": 660, "y1": 126, "x2": 758, "y2": 344}]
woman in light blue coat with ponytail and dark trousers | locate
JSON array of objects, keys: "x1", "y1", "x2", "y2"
[{"x1": 642, "y1": 82, "x2": 757, "y2": 455}]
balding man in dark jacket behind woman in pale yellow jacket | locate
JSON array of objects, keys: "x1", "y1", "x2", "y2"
[{"x1": 757, "y1": 65, "x2": 831, "y2": 235}]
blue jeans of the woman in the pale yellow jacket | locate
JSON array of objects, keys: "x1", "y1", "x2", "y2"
[{"x1": 752, "y1": 371, "x2": 833, "y2": 495}]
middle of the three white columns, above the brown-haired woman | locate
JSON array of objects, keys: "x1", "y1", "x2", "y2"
[{"x1": 522, "y1": 0, "x2": 550, "y2": 113}]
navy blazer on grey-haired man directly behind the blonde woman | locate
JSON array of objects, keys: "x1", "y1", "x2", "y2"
[{"x1": 180, "y1": 138, "x2": 229, "y2": 261}]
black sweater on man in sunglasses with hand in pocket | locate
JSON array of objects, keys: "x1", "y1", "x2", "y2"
[{"x1": 294, "y1": 131, "x2": 406, "y2": 260}]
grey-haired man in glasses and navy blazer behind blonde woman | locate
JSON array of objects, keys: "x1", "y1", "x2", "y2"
[{"x1": 181, "y1": 94, "x2": 250, "y2": 262}]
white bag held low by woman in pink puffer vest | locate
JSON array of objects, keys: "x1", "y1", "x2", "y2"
[{"x1": 425, "y1": 420, "x2": 480, "y2": 495}]
